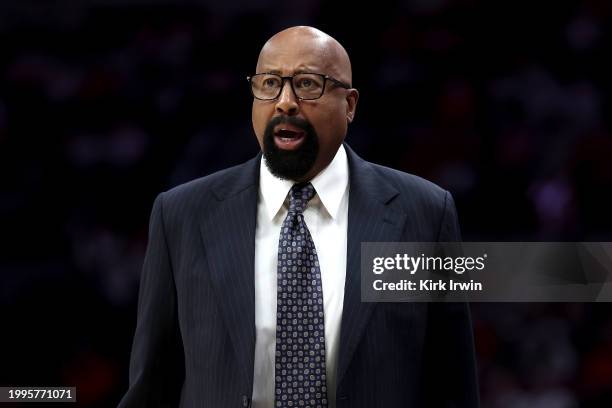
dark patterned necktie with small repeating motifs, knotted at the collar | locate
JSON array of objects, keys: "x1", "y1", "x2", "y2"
[{"x1": 274, "y1": 183, "x2": 327, "y2": 408}]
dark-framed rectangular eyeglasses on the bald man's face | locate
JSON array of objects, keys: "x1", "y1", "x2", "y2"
[{"x1": 247, "y1": 72, "x2": 350, "y2": 101}]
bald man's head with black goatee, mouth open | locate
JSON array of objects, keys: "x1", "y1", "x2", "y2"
[{"x1": 252, "y1": 26, "x2": 359, "y2": 181}]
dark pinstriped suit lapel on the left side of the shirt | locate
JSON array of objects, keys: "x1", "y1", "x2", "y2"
[{"x1": 200, "y1": 155, "x2": 261, "y2": 386}]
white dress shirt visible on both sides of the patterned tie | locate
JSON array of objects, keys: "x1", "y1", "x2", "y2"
[{"x1": 253, "y1": 145, "x2": 349, "y2": 408}]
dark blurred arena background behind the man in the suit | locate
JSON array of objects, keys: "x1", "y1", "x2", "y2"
[{"x1": 0, "y1": 0, "x2": 612, "y2": 408}]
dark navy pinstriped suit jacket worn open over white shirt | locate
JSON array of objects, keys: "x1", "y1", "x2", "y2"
[{"x1": 119, "y1": 145, "x2": 478, "y2": 408}]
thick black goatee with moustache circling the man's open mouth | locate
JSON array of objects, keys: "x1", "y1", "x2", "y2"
[{"x1": 263, "y1": 116, "x2": 319, "y2": 181}]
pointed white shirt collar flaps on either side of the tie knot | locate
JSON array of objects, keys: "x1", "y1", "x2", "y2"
[{"x1": 259, "y1": 145, "x2": 349, "y2": 220}]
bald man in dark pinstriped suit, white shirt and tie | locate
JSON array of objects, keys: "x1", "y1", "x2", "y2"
[{"x1": 119, "y1": 27, "x2": 478, "y2": 408}]
